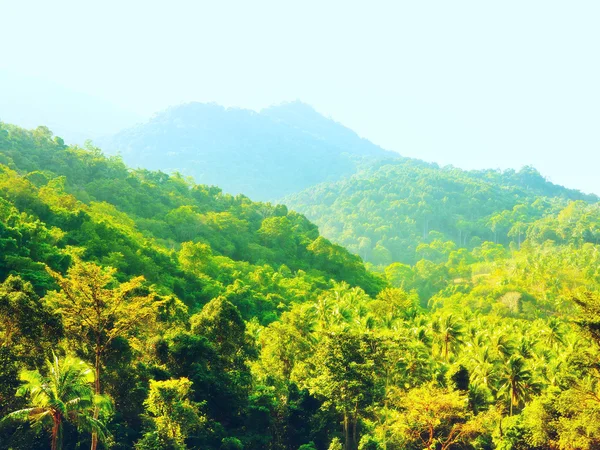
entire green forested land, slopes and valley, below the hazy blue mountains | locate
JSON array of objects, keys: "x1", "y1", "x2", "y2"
[{"x1": 0, "y1": 124, "x2": 600, "y2": 450}]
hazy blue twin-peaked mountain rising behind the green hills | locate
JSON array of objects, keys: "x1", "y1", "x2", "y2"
[{"x1": 96, "y1": 102, "x2": 397, "y2": 200}]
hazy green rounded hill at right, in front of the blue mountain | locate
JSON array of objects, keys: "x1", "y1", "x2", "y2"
[{"x1": 282, "y1": 158, "x2": 599, "y2": 265}]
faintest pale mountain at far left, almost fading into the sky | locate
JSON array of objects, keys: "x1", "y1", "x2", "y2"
[{"x1": 0, "y1": 71, "x2": 142, "y2": 144}]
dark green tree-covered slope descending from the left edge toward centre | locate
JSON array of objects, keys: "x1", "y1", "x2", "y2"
[{"x1": 0, "y1": 124, "x2": 382, "y2": 313}]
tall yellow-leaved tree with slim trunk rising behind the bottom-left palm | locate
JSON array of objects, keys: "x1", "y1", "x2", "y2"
[{"x1": 47, "y1": 258, "x2": 154, "y2": 450}]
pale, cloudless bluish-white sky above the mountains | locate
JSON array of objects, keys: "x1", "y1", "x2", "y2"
[{"x1": 0, "y1": 0, "x2": 600, "y2": 194}]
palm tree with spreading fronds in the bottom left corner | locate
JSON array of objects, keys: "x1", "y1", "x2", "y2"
[{"x1": 3, "y1": 355, "x2": 110, "y2": 450}]
